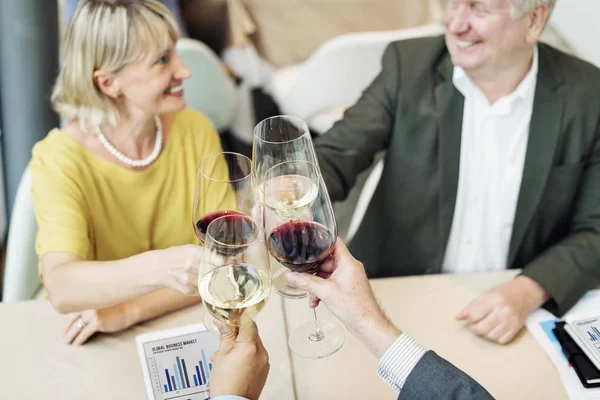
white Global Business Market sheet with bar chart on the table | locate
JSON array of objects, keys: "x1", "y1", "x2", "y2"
[{"x1": 135, "y1": 324, "x2": 219, "y2": 400}]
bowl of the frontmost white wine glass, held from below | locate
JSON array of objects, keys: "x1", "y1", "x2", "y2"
[{"x1": 198, "y1": 214, "x2": 271, "y2": 326}]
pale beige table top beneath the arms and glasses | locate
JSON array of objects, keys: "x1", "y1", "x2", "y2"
[{"x1": 0, "y1": 271, "x2": 567, "y2": 400}]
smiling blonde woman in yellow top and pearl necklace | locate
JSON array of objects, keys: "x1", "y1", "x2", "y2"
[{"x1": 30, "y1": 0, "x2": 232, "y2": 345}]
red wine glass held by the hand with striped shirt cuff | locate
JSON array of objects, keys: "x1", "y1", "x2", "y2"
[{"x1": 263, "y1": 161, "x2": 344, "y2": 359}]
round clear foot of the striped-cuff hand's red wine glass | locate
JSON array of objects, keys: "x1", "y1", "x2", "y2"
[{"x1": 288, "y1": 322, "x2": 344, "y2": 359}]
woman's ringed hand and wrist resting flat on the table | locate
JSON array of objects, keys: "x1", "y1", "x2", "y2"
[{"x1": 63, "y1": 304, "x2": 136, "y2": 346}]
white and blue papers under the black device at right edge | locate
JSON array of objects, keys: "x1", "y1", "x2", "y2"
[{"x1": 526, "y1": 290, "x2": 600, "y2": 400}]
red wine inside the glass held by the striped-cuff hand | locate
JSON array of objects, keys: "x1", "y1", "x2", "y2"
[{"x1": 267, "y1": 221, "x2": 335, "y2": 272}]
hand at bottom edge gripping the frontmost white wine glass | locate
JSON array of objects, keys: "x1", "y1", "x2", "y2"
[{"x1": 210, "y1": 321, "x2": 270, "y2": 400}]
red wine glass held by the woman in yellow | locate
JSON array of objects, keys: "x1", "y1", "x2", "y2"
[{"x1": 192, "y1": 153, "x2": 258, "y2": 331}]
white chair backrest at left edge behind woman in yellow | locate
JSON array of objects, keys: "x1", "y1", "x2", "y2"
[{"x1": 2, "y1": 167, "x2": 41, "y2": 302}]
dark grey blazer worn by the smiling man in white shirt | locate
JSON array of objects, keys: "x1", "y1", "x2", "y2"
[{"x1": 315, "y1": 37, "x2": 600, "y2": 314}]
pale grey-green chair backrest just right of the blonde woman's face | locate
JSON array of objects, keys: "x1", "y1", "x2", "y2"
[{"x1": 176, "y1": 38, "x2": 236, "y2": 131}]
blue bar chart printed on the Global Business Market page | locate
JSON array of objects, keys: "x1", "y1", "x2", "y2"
[{"x1": 161, "y1": 349, "x2": 212, "y2": 393}]
